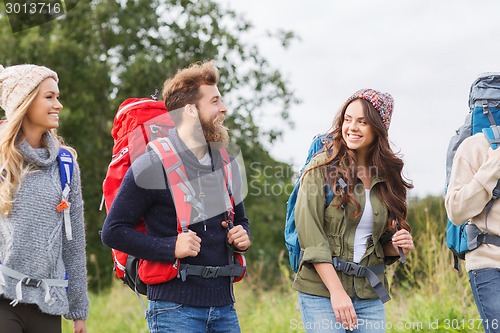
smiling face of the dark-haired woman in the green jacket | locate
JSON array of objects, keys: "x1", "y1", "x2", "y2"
[{"x1": 342, "y1": 100, "x2": 375, "y2": 156}]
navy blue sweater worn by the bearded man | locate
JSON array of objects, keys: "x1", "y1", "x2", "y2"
[{"x1": 101, "y1": 130, "x2": 250, "y2": 307}]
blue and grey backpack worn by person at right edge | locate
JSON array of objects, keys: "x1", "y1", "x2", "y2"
[{"x1": 445, "y1": 73, "x2": 500, "y2": 270}]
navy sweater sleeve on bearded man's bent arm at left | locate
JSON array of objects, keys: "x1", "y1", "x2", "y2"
[{"x1": 101, "y1": 153, "x2": 177, "y2": 262}]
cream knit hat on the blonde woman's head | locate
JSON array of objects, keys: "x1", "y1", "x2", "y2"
[{"x1": 0, "y1": 65, "x2": 59, "y2": 120}]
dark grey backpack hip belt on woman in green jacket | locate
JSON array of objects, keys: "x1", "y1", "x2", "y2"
[{"x1": 333, "y1": 257, "x2": 391, "y2": 303}]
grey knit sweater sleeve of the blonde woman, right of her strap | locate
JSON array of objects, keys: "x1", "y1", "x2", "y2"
[{"x1": 63, "y1": 162, "x2": 89, "y2": 320}]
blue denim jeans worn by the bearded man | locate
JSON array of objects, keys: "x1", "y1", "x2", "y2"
[{"x1": 146, "y1": 301, "x2": 240, "y2": 333}]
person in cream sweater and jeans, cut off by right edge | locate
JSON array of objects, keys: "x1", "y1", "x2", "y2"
[{"x1": 445, "y1": 113, "x2": 500, "y2": 333}]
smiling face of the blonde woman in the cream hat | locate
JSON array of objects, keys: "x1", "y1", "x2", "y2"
[{"x1": 22, "y1": 78, "x2": 63, "y2": 136}]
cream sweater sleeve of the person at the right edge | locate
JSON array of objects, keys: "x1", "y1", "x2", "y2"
[{"x1": 445, "y1": 133, "x2": 500, "y2": 225}]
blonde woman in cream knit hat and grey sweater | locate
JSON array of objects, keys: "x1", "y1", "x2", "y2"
[{"x1": 0, "y1": 65, "x2": 89, "y2": 333}]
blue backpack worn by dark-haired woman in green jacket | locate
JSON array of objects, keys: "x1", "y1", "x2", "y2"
[{"x1": 284, "y1": 134, "x2": 333, "y2": 273}]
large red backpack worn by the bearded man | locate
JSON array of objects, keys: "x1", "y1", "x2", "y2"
[{"x1": 101, "y1": 98, "x2": 246, "y2": 295}]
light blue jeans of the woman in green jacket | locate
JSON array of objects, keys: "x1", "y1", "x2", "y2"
[{"x1": 299, "y1": 292, "x2": 386, "y2": 333}]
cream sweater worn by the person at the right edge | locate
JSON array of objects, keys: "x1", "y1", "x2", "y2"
[{"x1": 445, "y1": 133, "x2": 500, "y2": 271}]
